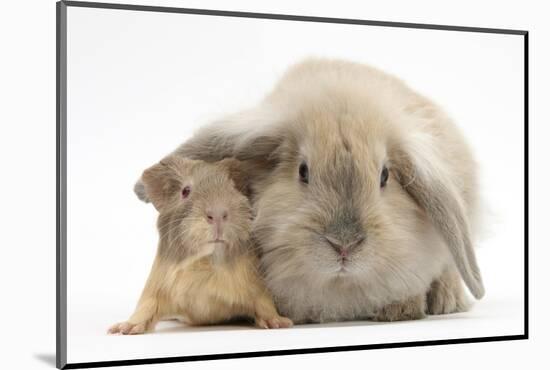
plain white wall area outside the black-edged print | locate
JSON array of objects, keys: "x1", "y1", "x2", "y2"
[{"x1": 2, "y1": 1, "x2": 548, "y2": 368}]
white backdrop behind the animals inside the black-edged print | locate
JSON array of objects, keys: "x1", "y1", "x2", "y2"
[{"x1": 67, "y1": 3, "x2": 524, "y2": 362}]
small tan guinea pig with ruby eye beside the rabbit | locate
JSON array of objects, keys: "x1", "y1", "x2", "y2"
[{"x1": 109, "y1": 156, "x2": 292, "y2": 334}]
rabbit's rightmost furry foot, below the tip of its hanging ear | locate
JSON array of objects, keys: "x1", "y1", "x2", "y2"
[{"x1": 427, "y1": 271, "x2": 470, "y2": 315}]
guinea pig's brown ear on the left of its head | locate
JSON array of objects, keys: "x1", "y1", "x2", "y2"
[{"x1": 141, "y1": 156, "x2": 196, "y2": 211}]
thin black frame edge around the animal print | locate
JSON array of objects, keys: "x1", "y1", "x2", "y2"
[{"x1": 56, "y1": 0, "x2": 529, "y2": 369}]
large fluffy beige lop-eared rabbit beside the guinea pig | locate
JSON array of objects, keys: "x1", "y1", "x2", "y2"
[{"x1": 135, "y1": 58, "x2": 485, "y2": 323}]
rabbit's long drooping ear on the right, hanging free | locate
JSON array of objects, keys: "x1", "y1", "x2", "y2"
[{"x1": 392, "y1": 142, "x2": 485, "y2": 299}]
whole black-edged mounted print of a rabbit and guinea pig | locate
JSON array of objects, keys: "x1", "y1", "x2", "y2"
[{"x1": 57, "y1": 1, "x2": 528, "y2": 368}]
